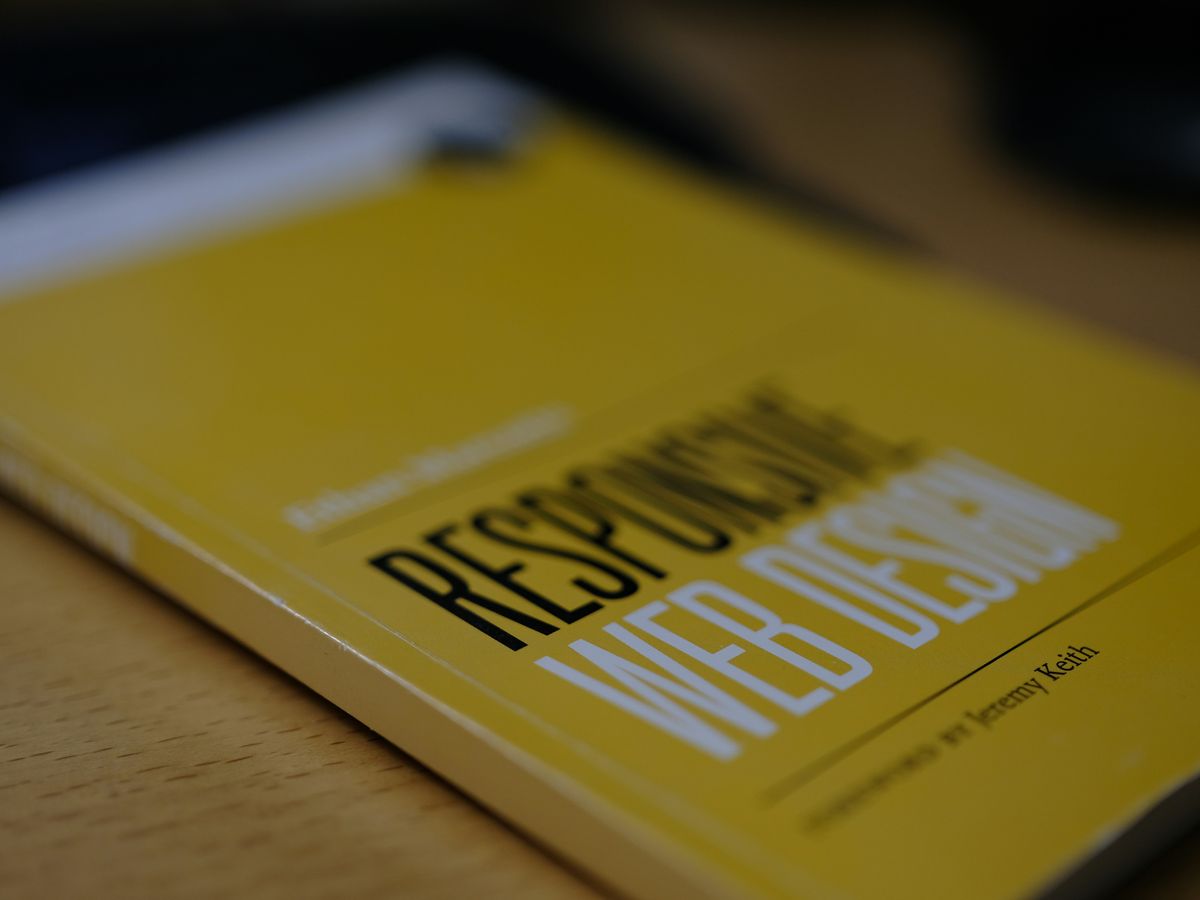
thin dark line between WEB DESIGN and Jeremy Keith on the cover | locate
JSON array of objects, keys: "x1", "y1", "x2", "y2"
[{"x1": 762, "y1": 528, "x2": 1200, "y2": 806}]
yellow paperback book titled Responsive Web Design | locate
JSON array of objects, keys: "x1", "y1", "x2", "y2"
[{"x1": 0, "y1": 65, "x2": 1200, "y2": 899}]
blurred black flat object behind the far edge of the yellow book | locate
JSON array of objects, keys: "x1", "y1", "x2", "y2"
[{"x1": 0, "y1": 10, "x2": 895, "y2": 240}]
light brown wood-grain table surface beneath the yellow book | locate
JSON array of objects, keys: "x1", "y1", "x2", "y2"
[{"x1": 0, "y1": 5, "x2": 1200, "y2": 898}]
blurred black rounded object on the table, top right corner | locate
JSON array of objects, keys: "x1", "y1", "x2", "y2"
[{"x1": 947, "y1": 0, "x2": 1200, "y2": 210}]
